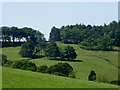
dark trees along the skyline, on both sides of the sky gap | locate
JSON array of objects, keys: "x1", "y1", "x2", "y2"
[{"x1": 0, "y1": 21, "x2": 120, "y2": 50}]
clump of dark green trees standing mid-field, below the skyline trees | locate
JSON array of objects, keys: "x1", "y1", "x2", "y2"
[{"x1": 19, "y1": 39, "x2": 77, "y2": 60}]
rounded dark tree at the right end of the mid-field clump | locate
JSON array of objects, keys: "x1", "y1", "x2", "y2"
[{"x1": 61, "y1": 46, "x2": 77, "y2": 60}]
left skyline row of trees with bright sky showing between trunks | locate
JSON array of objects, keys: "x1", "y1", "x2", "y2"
[{"x1": 0, "y1": 26, "x2": 45, "y2": 46}]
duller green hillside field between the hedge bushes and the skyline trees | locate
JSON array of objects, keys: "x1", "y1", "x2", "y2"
[{"x1": 0, "y1": 42, "x2": 118, "y2": 81}]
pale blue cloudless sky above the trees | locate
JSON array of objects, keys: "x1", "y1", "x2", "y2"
[{"x1": 0, "y1": 2, "x2": 118, "y2": 40}]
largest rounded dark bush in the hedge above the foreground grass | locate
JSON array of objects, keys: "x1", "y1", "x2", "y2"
[{"x1": 48, "y1": 63, "x2": 73, "y2": 77}]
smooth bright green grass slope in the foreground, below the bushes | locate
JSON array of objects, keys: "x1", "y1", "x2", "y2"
[{"x1": 3, "y1": 67, "x2": 118, "y2": 88}]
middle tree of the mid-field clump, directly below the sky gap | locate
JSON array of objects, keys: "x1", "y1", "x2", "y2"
[{"x1": 45, "y1": 42, "x2": 60, "y2": 59}]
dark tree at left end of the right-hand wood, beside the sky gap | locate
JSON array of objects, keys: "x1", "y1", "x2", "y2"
[{"x1": 49, "y1": 27, "x2": 61, "y2": 41}]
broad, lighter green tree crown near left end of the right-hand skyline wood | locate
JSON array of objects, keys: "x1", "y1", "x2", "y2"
[{"x1": 60, "y1": 24, "x2": 85, "y2": 44}]
